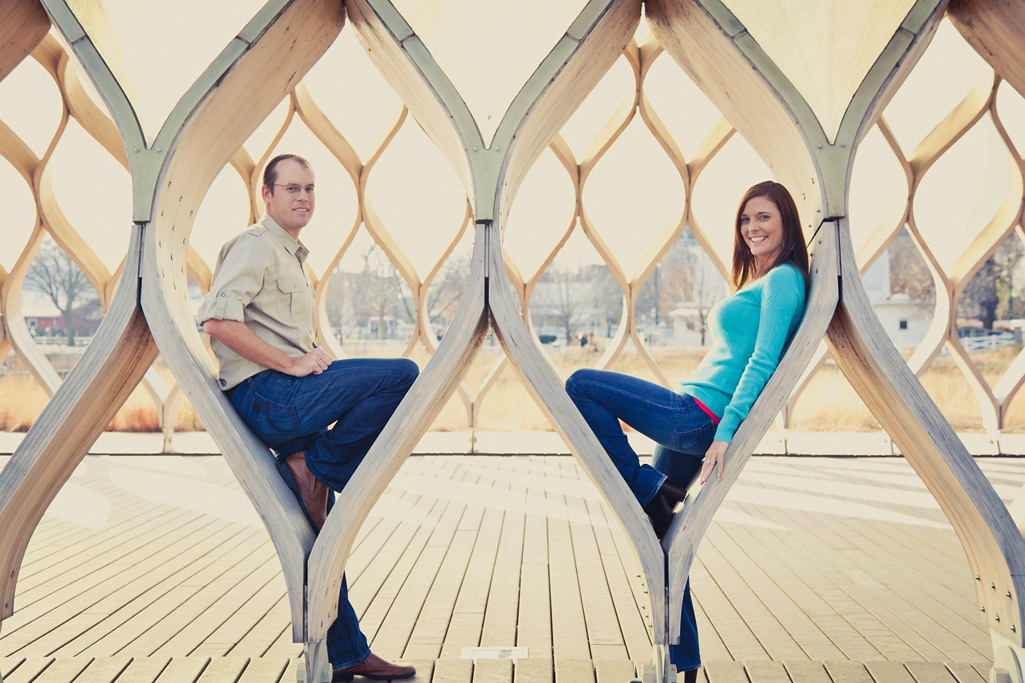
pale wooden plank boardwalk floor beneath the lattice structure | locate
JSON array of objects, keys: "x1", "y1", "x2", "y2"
[{"x1": 0, "y1": 455, "x2": 1012, "y2": 683}]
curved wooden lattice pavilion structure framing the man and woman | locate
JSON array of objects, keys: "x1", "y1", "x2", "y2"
[{"x1": 0, "y1": 0, "x2": 1025, "y2": 682}]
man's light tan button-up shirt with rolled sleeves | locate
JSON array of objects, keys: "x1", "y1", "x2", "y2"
[{"x1": 199, "y1": 215, "x2": 317, "y2": 391}]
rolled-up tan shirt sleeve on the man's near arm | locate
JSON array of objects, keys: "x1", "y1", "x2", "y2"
[{"x1": 199, "y1": 233, "x2": 267, "y2": 324}]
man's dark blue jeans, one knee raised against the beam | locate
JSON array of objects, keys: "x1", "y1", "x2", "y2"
[{"x1": 232, "y1": 358, "x2": 419, "y2": 669}]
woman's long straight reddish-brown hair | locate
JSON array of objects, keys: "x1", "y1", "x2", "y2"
[{"x1": 733, "y1": 180, "x2": 809, "y2": 289}]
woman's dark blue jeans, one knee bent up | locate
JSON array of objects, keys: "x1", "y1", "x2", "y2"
[{"x1": 566, "y1": 369, "x2": 715, "y2": 671}]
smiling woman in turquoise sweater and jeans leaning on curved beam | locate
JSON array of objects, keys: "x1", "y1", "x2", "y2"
[{"x1": 566, "y1": 180, "x2": 808, "y2": 683}]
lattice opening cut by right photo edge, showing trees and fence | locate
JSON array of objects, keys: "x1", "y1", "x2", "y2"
[{"x1": 955, "y1": 232, "x2": 1025, "y2": 395}]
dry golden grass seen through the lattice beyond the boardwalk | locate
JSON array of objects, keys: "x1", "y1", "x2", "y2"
[{"x1": 8, "y1": 340, "x2": 1025, "y2": 433}]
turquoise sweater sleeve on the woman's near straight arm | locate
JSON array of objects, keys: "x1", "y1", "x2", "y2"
[{"x1": 715, "y1": 266, "x2": 805, "y2": 442}]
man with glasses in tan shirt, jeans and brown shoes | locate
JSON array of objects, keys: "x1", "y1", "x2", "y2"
[{"x1": 199, "y1": 154, "x2": 419, "y2": 681}]
